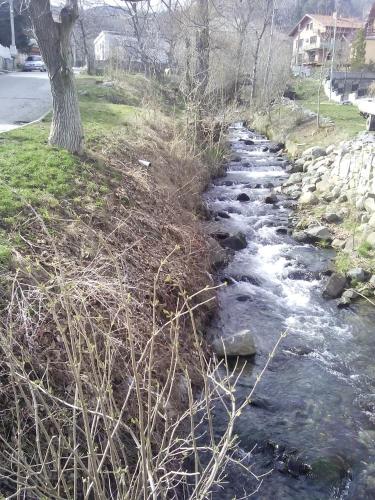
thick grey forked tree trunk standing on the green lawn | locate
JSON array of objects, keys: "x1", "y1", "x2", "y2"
[{"x1": 29, "y1": 0, "x2": 83, "y2": 154}]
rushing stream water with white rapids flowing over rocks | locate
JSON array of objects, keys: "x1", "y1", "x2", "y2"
[{"x1": 206, "y1": 125, "x2": 375, "y2": 500}]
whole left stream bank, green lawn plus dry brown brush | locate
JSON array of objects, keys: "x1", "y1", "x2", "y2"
[{"x1": 0, "y1": 72, "x2": 229, "y2": 498}]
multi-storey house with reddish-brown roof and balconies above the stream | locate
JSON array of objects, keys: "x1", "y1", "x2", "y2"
[{"x1": 289, "y1": 14, "x2": 363, "y2": 68}]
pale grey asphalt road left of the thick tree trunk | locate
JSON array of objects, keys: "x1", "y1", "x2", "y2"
[{"x1": 0, "y1": 72, "x2": 51, "y2": 133}]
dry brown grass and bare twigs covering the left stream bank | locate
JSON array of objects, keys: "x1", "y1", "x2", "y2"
[{"x1": 0, "y1": 76, "x2": 261, "y2": 499}]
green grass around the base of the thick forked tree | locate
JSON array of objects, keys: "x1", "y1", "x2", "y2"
[{"x1": 0, "y1": 77, "x2": 148, "y2": 260}]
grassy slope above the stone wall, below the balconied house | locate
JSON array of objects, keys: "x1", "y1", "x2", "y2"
[{"x1": 254, "y1": 78, "x2": 366, "y2": 156}]
